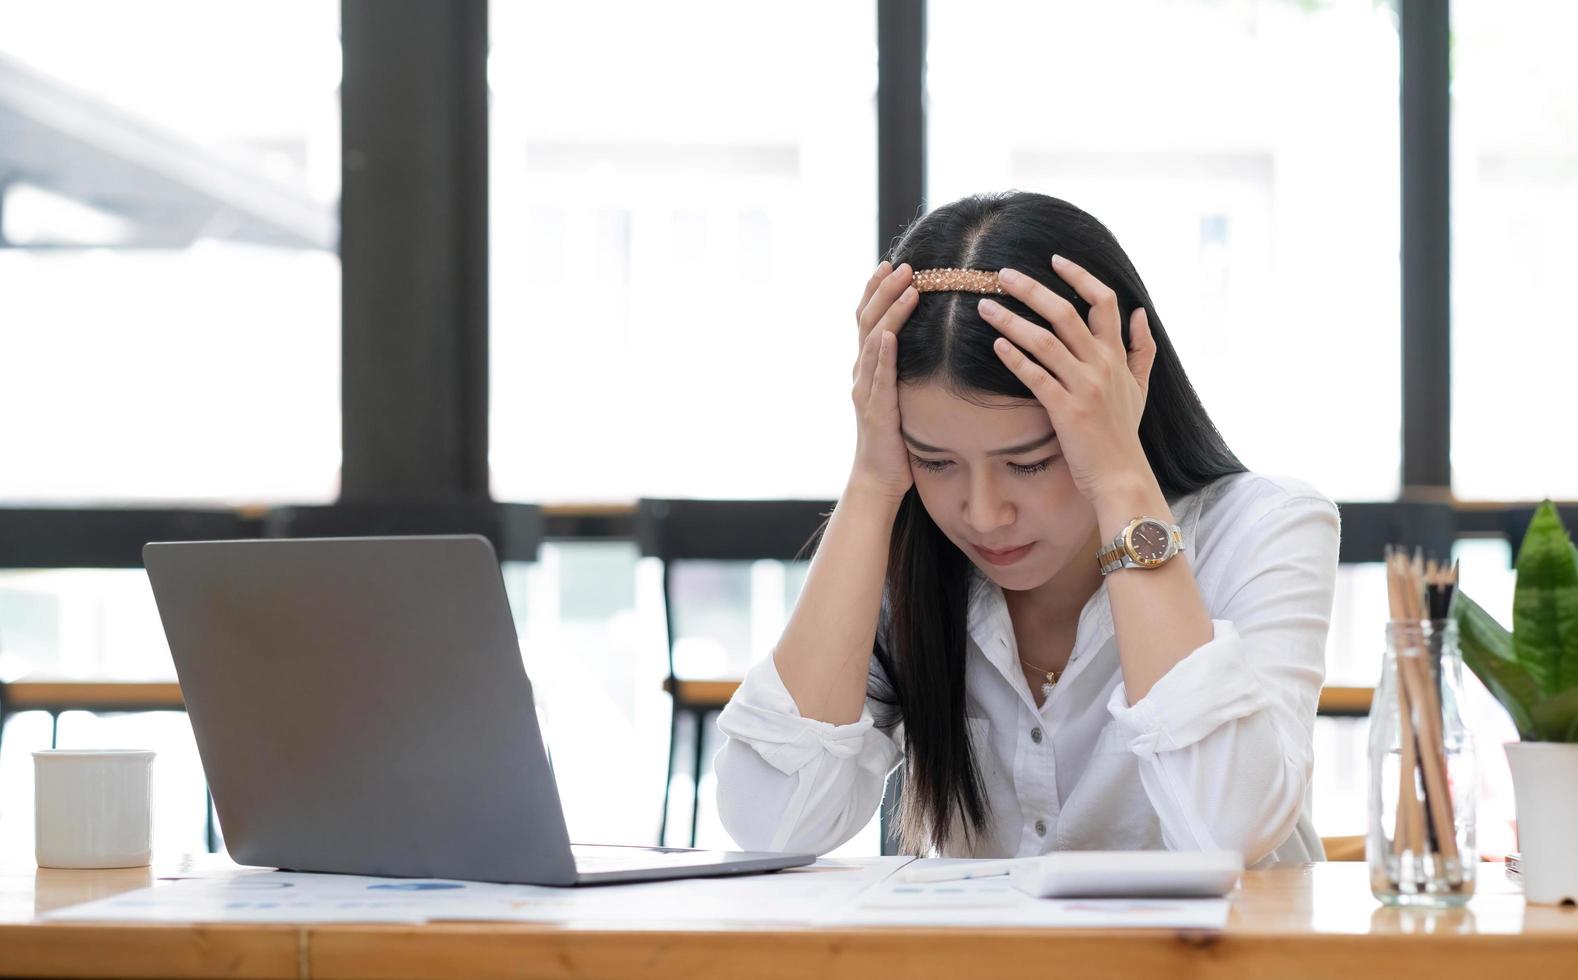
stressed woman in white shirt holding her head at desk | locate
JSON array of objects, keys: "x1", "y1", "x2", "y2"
[{"x1": 716, "y1": 193, "x2": 1338, "y2": 865}]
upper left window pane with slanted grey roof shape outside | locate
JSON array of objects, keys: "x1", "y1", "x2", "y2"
[{"x1": 0, "y1": 0, "x2": 339, "y2": 503}]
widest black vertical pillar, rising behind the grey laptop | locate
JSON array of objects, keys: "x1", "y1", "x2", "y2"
[{"x1": 339, "y1": 0, "x2": 488, "y2": 502}]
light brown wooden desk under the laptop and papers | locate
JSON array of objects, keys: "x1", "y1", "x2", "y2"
[{"x1": 0, "y1": 855, "x2": 1578, "y2": 980}]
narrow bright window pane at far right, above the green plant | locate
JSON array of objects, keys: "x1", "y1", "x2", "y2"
[{"x1": 1452, "y1": 0, "x2": 1578, "y2": 500}]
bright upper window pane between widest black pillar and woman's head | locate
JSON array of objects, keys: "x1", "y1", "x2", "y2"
[{"x1": 488, "y1": 0, "x2": 876, "y2": 500}]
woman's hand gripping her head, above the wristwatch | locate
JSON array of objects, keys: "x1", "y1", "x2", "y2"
[{"x1": 980, "y1": 256, "x2": 1157, "y2": 503}]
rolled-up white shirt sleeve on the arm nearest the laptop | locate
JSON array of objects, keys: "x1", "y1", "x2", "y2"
[{"x1": 715, "y1": 656, "x2": 903, "y2": 854}]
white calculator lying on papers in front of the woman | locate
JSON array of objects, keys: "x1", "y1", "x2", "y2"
[{"x1": 1008, "y1": 851, "x2": 1243, "y2": 898}]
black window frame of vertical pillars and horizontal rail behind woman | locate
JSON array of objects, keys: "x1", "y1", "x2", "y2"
[{"x1": 0, "y1": 0, "x2": 1578, "y2": 568}]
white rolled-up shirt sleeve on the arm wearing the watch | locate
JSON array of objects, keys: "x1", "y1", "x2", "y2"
[{"x1": 1108, "y1": 496, "x2": 1340, "y2": 863}]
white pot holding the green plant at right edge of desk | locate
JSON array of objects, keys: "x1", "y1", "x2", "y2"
[{"x1": 1507, "y1": 742, "x2": 1578, "y2": 904}]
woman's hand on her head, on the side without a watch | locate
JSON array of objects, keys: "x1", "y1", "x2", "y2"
[{"x1": 851, "y1": 262, "x2": 920, "y2": 500}]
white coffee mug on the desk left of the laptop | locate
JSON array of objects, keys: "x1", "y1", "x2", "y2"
[{"x1": 33, "y1": 748, "x2": 153, "y2": 868}]
